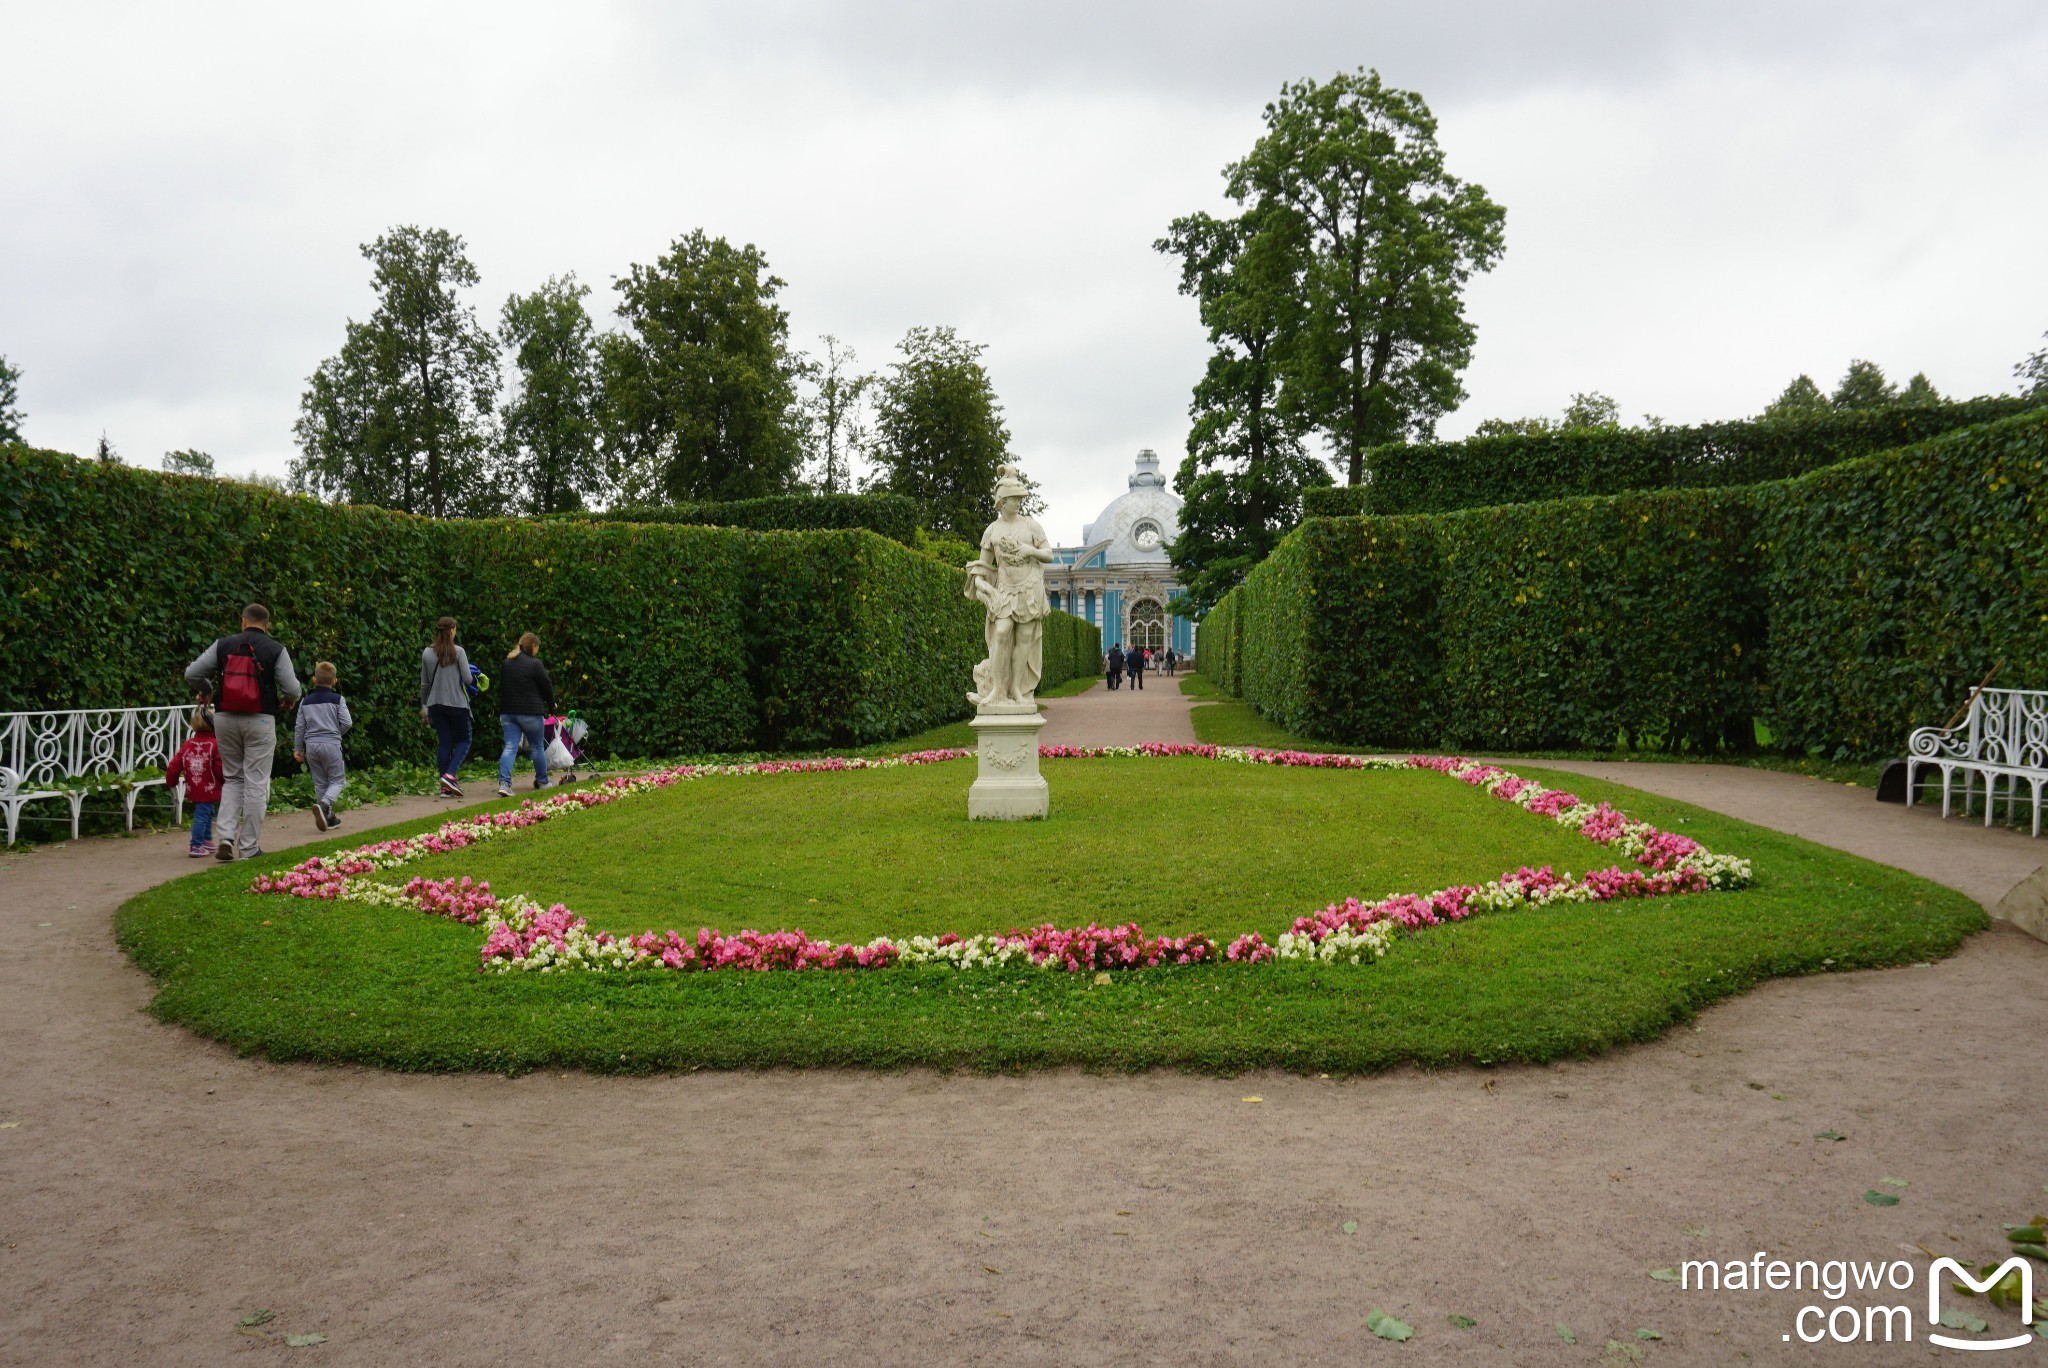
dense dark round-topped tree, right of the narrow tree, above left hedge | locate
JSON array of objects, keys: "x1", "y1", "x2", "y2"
[{"x1": 598, "y1": 229, "x2": 803, "y2": 502}]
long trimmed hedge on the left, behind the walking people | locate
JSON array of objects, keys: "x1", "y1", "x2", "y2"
[{"x1": 0, "y1": 454, "x2": 1098, "y2": 764}]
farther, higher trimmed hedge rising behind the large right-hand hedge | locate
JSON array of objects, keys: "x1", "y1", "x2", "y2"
[{"x1": 1303, "y1": 397, "x2": 2038, "y2": 518}]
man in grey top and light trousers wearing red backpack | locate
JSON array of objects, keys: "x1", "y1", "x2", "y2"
[{"x1": 184, "y1": 604, "x2": 299, "y2": 864}]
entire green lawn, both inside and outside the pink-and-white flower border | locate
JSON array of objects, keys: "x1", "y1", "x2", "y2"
[{"x1": 119, "y1": 760, "x2": 1985, "y2": 1073}]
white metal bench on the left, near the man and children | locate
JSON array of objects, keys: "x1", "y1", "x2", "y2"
[{"x1": 0, "y1": 707, "x2": 193, "y2": 846}]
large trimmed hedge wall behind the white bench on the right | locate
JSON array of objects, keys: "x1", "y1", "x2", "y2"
[{"x1": 1200, "y1": 410, "x2": 2048, "y2": 756}]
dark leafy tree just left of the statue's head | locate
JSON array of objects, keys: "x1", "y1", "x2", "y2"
[{"x1": 874, "y1": 328, "x2": 1010, "y2": 543}]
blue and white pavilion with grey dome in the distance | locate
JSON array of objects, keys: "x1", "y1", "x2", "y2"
[{"x1": 1044, "y1": 448, "x2": 1194, "y2": 657}]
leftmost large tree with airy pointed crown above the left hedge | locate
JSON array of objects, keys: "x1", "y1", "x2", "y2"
[{"x1": 291, "y1": 225, "x2": 502, "y2": 518}]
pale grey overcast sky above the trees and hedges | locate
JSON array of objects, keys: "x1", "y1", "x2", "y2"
[{"x1": 0, "y1": 0, "x2": 2048, "y2": 541}]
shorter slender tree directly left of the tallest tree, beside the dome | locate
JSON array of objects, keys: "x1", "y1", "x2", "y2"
[{"x1": 1153, "y1": 209, "x2": 1331, "y2": 616}]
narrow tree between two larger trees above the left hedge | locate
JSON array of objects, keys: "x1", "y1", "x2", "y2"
[{"x1": 498, "y1": 274, "x2": 604, "y2": 514}]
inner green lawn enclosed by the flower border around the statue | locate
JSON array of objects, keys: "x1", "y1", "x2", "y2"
[{"x1": 393, "y1": 760, "x2": 1597, "y2": 942}]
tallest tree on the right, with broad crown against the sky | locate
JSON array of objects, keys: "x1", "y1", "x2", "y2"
[{"x1": 1225, "y1": 70, "x2": 1507, "y2": 485}]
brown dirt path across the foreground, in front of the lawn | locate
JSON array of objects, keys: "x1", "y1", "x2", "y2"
[{"x1": 0, "y1": 774, "x2": 2048, "y2": 1366}]
